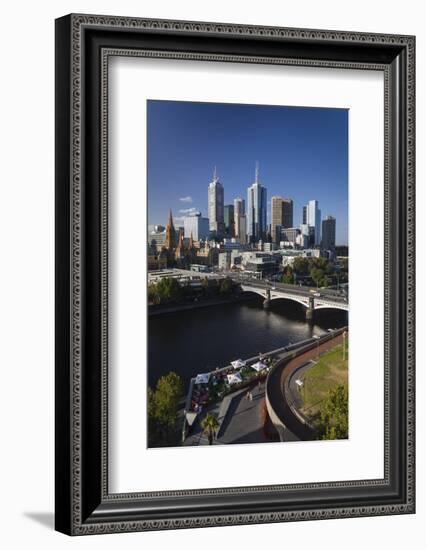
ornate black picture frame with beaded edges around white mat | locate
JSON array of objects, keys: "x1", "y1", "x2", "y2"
[{"x1": 56, "y1": 15, "x2": 415, "y2": 535}]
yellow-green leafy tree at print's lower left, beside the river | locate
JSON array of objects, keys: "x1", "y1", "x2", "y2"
[{"x1": 148, "y1": 372, "x2": 184, "y2": 446}]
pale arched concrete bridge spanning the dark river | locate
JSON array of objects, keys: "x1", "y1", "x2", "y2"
[{"x1": 235, "y1": 279, "x2": 349, "y2": 319}]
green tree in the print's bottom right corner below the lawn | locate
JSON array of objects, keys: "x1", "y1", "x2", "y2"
[{"x1": 317, "y1": 384, "x2": 348, "y2": 439}]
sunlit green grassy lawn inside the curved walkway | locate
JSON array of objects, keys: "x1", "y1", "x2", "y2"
[{"x1": 300, "y1": 341, "x2": 349, "y2": 417}]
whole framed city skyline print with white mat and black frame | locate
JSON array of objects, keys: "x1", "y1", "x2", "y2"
[{"x1": 56, "y1": 15, "x2": 415, "y2": 535}]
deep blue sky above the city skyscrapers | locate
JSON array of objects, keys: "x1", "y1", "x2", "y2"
[{"x1": 147, "y1": 99, "x2": 348, "y2": 244}]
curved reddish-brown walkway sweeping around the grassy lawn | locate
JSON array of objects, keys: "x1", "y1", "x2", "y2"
[{"x1": 266, "y1": 327, "x2": 347, "y2": 441}]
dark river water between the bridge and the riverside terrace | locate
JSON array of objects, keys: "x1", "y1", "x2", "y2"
[{"x1": 148, "y1": 299, "x2": 347, "y2": 388}]
